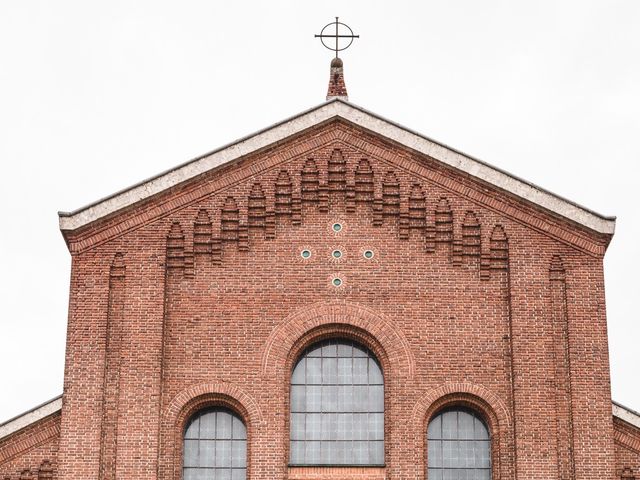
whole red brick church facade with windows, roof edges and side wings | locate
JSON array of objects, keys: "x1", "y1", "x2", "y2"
[{"x1": 0, "y1": 61, "x2": 640, "y2": 480}]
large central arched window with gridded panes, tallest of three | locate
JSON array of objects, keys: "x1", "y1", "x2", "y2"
[{"x1": 290, "y1": 340, "x2": 384, "y2": 465}]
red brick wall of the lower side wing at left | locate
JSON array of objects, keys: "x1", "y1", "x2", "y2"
[{"x1": 0, "y1": 412, "x2": 60, "y2": 480}]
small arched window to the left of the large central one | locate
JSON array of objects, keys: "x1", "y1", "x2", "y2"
[{"x1": 183, "y1": 408, "x2": 247, "y2": 480}]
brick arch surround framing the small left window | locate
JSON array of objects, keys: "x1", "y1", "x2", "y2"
[{"x1": 158, "y1": 382, "x2": 264, "y2": 479}]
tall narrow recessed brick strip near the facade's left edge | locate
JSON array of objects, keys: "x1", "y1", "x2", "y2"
[{"x1": 98, "y1": 253, "x2": 126, "y2": 480}]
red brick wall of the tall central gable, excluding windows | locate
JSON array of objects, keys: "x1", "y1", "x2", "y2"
[{"x1": 60, "y1": 122, "x2": 615, "y2": 480}]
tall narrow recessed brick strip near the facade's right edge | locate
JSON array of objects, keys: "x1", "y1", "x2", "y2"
[{"x1": 549, "y1": 255, "x2": 575, "y2": 480}]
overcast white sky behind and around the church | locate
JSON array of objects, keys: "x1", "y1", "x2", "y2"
[{"x1": 0, "y1": 0, "x2": 640, "y2": 423}]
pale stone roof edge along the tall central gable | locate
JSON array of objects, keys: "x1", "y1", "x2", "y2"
[{"x1": 58, "y1": 98, "x2": 615, "y2": 235}]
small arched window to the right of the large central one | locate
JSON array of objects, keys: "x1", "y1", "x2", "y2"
[{"x1": 427, "y1": 408, "x2": 491, "y2": 480}]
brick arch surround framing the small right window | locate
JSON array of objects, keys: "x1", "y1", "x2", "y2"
[{"x1": 411, "y1": 382, "x2": 512, "y2": 480}]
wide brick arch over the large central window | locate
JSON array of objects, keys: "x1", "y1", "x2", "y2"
[{"x1": 261, "y1": 300, "x2": 415, "y2": 378}]
